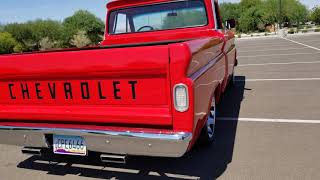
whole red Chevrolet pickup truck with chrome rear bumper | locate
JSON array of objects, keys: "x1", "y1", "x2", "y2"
[{"x1": 0, "y1": 0, "x2": 237, "y2": 162}]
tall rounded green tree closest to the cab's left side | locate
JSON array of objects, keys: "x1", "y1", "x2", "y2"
[{"x1": 62, "y1": 10, "x2": 104, "y2": 45}]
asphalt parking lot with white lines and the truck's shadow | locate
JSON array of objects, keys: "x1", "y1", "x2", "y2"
[{"x1": 0, "y1": 34, "x2": 320, "y2": 180}]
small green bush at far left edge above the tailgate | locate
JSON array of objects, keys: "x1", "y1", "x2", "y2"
[{"x1": 0, "y1": 32, "x2": 17, "y2": 54}]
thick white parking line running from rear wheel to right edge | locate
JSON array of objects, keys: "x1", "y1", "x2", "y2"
[{"x1": 217, "y1": 117, "x2": 320, "y2": 124}]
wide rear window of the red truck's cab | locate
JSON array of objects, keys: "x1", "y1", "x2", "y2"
[{"x1": 109, "y1": 0, "x2": 208, "y2": 34}]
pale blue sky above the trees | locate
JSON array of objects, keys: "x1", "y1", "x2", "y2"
[{"x1": 0, "y1": 0, "x2": 320, "y2": 24}]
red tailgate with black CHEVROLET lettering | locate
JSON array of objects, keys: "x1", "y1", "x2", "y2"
[{"x1": 0, "y1": 45, "x2": 172, "y2": 125}]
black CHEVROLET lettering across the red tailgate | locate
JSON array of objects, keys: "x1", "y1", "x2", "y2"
[{"x1": 5, "y1": 81, "x2": 138, "y2": 100}]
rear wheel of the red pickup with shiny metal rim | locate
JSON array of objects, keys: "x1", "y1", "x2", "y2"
[{"x1": 200, "y1": 98, "x2": 216, "y2": 144}]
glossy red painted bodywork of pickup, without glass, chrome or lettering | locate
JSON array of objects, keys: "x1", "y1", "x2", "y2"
[{"x1": 0, "y1": 0, "x2": 236, "y2": 154}]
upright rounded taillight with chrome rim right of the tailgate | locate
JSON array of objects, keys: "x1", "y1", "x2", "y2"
[{"x1": 173, "y1": 84, "x2": 189, "y2": 112}]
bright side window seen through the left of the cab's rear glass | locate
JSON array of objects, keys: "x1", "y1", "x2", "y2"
[{"x1": 112, "y1": 13, "x2": 131, "y2": 34}]
